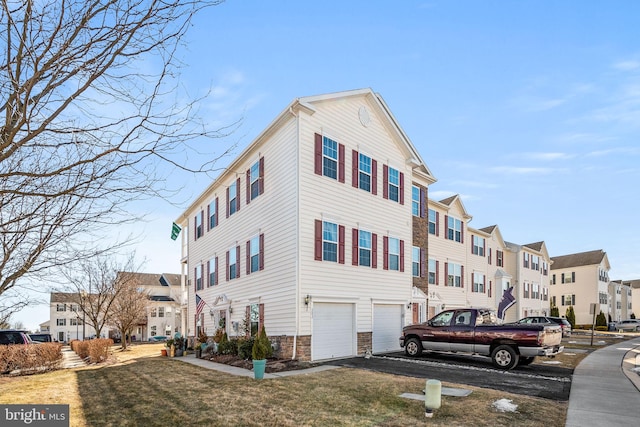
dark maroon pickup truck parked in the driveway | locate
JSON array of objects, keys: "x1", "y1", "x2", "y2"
[{"x1": 400, "y1": 308, "x2": 564, "y2": 370}]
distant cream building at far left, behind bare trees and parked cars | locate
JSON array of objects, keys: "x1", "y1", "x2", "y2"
[{"x1": 49, "y1": 292, "x2": 103, "y2": 342}]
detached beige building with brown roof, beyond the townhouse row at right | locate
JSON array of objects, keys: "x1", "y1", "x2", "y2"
[{"x1": 550, "y1": 249, "x2": 615, "y2": 325}]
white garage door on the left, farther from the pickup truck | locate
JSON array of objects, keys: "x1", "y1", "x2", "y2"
[{"x1": 311, "y1": 303, "x2": 355, "y2": 360}]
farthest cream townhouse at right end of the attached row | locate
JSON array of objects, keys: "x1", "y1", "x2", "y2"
[{"x1": 505, "y1": 242, "x2": 552, "y2": 322}]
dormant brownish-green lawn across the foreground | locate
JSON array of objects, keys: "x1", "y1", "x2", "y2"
[{"x1": 0, "y1": 344, "x2": 567, "y2": 427}]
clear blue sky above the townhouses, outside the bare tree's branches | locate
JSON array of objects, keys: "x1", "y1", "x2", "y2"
[{"x1": 14, "y1": 0, "x2": 640, "y2": 327}]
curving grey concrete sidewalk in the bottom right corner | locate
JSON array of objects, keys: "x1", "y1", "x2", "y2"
[{"x1": 566, "y1": 338, "x2": 640, "y2": 427}]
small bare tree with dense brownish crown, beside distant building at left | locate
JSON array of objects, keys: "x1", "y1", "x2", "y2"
[{"x1": 109, "y1": 272, "x2": 150, "y2": 350}]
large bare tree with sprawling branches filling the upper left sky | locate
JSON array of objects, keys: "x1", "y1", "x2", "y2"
[{"x1": 0, "y1": 0, "x2": 235, "y2": 306}]
